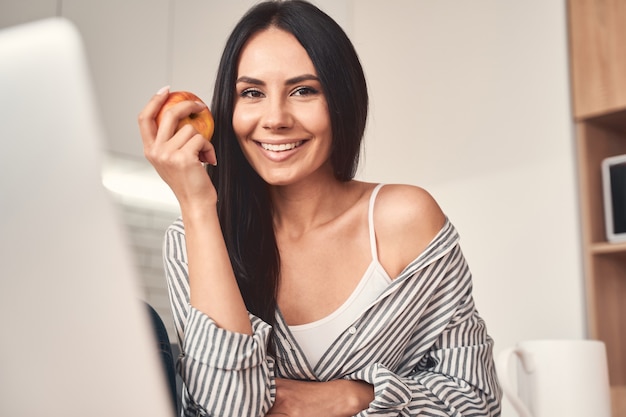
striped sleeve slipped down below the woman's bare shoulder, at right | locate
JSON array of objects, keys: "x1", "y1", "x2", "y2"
[{"x1": 347, "y1": 236, "x2": 501, "y2": 417}]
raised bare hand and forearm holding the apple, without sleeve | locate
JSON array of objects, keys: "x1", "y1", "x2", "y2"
[{"x1": 139, "y1": 85, "x2": 252, "y2": 334}]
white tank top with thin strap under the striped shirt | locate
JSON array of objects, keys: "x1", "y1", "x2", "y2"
[{"x1": 289, "y1": 184, "x2": 391, "y2": 367}]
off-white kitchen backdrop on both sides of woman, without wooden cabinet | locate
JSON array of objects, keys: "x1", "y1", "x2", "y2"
[{"x1": 0, "y1": 0, "x2": 586, "y2": 417}]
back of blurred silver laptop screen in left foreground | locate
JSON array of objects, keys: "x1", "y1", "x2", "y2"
[{"x1": 0, "y1": 18, "x2": 173, "y2": 417}]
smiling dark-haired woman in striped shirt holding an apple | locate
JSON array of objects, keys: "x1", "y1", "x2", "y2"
[{"x1": 139, "y1": 1, "x2": 500, "y2": 416}]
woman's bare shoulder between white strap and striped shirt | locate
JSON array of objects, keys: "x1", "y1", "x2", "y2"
[{"x1": 374, "y1": 184, "x2": 445, "y2": 278}]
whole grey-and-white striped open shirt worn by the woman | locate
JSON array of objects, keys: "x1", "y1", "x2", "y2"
[{"x1": 164, "y1": 219, "x2": 501, "y2": 417}]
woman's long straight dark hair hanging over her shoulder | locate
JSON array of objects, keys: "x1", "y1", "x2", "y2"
[{"x1": 208, "y1": 0, "x2": 368, "y2": 324}]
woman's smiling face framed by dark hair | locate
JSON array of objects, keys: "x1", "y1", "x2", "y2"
[{"x1": 233, "y1": 28, "x2": 332, "y2": 185}]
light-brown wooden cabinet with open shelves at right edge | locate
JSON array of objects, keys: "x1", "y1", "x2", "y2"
[{"x1": 568, "y1": 0, "x2": 626, "y2": 417}]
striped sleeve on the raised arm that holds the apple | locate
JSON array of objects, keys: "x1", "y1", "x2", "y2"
[{"x1": 163, "y1": 220, "x2": 275, "y2": 417}]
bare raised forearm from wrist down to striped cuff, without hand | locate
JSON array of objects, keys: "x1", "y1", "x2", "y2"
[{"x1": 182, "y1": 202, "x2": 252, "y2": 335}]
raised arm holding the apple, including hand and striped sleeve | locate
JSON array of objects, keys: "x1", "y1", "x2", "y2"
[{"x1": 139, "y1": 89, "x2": 274, "y2": 417}]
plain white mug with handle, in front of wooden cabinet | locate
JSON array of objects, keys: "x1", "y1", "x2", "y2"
[{"x1": 496, "y1": 340, "x2": 611, "y2": 417}]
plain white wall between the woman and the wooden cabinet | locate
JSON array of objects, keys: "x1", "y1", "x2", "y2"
[{"x1": 352, "y1": 0, "x2": 585, "y2": 416}]
